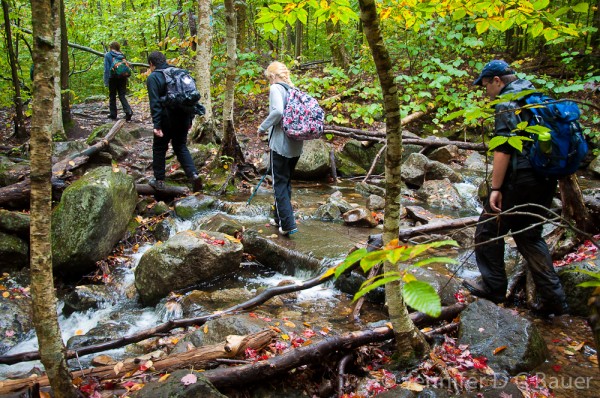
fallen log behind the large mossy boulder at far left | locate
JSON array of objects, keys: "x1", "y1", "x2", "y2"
[{"x1": 0, "y1": 119, "x2": 125, "y2": 207}]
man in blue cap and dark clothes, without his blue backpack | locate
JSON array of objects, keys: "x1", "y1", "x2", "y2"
[{"x1": 463, "y1": 60, "x2": 568, "y2": 316}]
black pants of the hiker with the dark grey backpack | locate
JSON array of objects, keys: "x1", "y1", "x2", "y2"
[{"x1": 152, "y1": 119, "x2": 197, "y2": 180}]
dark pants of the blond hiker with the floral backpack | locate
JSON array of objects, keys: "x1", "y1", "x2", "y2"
[{"x1": 271, "y1": 150, "x2": 300, "y2": 231}]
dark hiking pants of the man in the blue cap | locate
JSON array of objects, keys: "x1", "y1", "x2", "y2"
[{"x1": 475, "y1": 169, "x2": 565, "y2": 310}]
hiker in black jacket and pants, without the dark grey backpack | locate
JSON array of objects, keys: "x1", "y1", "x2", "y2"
[{"x1": 146, "y1": 51, "x2": 202, "y2": 192}]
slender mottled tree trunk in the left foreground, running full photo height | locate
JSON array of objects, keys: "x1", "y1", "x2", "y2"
[{"x1": 30, "y1": 0, "x2": 78, "y2": 398}]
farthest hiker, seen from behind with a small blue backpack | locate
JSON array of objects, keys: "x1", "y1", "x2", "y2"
[{"x1": 104, "y1": 41, "x2": 133, "y2": 122}]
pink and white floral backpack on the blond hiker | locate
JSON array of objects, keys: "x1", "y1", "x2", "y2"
[{"x1": 278, "y1": 83, "x2": 325, "y2": 141}]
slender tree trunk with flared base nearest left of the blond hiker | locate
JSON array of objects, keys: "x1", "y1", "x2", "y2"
[{"x1": 215, "y1": 0, "x2": 244, "y2": 164}]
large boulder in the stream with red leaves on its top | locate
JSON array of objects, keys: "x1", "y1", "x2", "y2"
[{"x1": 135, "y1": 231, "x2": 243, "y2": 305}]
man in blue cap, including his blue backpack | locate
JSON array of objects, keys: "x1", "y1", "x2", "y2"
[{"x1": 463, "y1": 60, "x2": 587, "y2": 317}]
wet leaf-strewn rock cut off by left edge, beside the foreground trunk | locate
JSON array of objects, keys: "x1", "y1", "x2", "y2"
[{"x1": 0, "y1": 278, "x2": 33, "y2": 355}]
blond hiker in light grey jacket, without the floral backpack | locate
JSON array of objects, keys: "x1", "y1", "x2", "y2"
[{"x1": 258, "y1": 62, "x2": 303, "y2": 236}]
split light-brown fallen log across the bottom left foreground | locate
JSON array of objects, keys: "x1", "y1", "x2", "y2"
[{"x1": 0, "y1": 329, "x2": 277, "y2": 396}]
